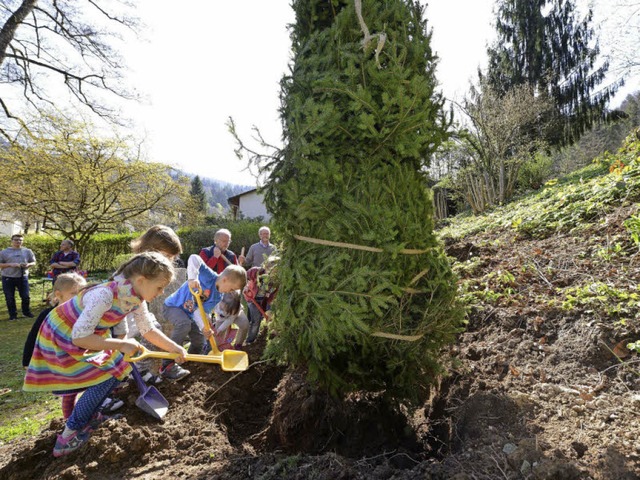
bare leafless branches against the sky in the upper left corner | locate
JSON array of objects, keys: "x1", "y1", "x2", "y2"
[{"x1": 0, "y1": 0, "x2": 136, "y2": 139}]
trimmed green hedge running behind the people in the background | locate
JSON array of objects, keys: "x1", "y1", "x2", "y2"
[{"x1": 0, "y1": 220, "x2": 274, "y2": 276}]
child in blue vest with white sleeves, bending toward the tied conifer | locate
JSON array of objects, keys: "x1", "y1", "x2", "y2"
[{"x1": 160, "y1": 255, "x2": 247, "y2": 380}]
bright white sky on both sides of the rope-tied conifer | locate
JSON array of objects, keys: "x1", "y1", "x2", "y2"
[{"x1": 124, "y1": 0, "x2": 632, "y2": 185}]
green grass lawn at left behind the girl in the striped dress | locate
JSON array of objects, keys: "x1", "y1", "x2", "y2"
[{"x1": 0, "y1": 278, "x2": 62, "y2": 444}]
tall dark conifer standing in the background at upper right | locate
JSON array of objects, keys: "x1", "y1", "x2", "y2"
[{"x1": 487, "y1": 0, "x2": 617, "y2": 145}]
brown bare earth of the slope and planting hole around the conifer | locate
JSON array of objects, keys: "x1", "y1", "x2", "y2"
[{"x1": 0, "y1": 221, "x2": 640, "y2": 480}]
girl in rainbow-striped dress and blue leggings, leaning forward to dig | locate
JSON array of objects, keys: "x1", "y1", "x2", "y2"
[{"x1": 23, "y1": 252, "x2": 186, "y2": 457}]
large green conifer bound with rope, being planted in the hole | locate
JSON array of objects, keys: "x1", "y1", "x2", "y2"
[{"x1": 264, "y1": 0, "x2": 463, "y2": 397}]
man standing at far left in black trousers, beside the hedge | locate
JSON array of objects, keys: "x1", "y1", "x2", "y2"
[{"x1": 0, "y1": 234, "x2": 36, "y2": 320}]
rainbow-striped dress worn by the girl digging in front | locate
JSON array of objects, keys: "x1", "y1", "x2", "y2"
[{"x1": 23, "y1": 278, "x2": 142, "y2": 392}]
